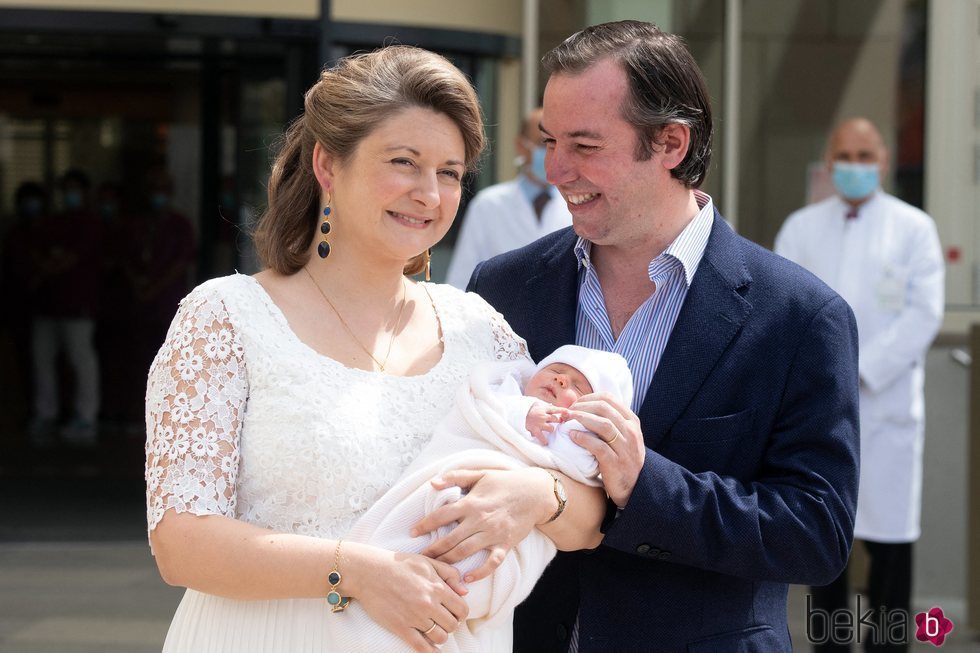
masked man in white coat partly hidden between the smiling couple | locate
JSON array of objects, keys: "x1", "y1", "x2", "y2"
[{"x1": 446, "y1": 107, "x2": 572, "y2": 288}]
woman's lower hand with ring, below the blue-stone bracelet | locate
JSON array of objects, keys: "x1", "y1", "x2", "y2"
[{"x1": 341, "y1": 542, "x2": 469, "y2": 653}]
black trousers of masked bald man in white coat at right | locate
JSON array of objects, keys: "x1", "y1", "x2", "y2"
[{"x1": 810, "y1": 540, "x2": 915, "y2": 653}]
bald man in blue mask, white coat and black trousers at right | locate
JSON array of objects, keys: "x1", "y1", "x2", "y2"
[{"x1": 775, "y1": 118, "x2": 944, "y2": 651}]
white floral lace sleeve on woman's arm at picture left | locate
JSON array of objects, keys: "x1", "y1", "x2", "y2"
[{"x1": 146, "y1": 290, "x2": 248, "y2": 533}]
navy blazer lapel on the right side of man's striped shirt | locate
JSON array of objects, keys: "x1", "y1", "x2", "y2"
[{"x1": 639, "y1": 211, "x2": 752, "y2": 449}]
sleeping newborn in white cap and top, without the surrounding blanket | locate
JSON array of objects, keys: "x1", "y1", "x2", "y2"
[{"x1": 499, "y1": 345, "x2": 633, "y2": 478}]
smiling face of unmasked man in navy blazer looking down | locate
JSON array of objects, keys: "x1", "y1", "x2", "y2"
[{"x1": 542, "y1": 60, "x2": 671, "y2": 246}]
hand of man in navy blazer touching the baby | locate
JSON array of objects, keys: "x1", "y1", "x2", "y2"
[{"x1": 568, "y1": 393, "x2": 646, "y2": 508}]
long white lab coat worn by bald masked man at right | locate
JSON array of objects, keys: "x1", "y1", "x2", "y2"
[{"x1": 775, "y1": 190, "x2": 945, "y2": 542}]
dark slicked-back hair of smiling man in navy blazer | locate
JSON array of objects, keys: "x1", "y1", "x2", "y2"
[{"x1": 542, "y1": 20, "x2": 712, "y2": 188}]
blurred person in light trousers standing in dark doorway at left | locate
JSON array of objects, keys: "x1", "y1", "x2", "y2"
[{"x1": 28, "y1": 168, "x2": 102, "y2": 445}]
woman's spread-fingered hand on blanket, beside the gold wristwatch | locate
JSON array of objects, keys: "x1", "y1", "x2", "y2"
[{"x1": 412, "y1": 467, "x2": 556, "y2": 583}]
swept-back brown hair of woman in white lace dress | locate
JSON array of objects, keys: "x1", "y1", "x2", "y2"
[{"x1": 254, "y1": 45, "x2": 484, "y2": 275}]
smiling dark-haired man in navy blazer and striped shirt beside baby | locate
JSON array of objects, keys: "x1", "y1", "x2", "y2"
[{"x1": 470, "y1": 21, "x2": 858, "y2": 653}]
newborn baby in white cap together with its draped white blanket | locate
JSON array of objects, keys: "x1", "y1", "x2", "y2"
[{"x1": 344, "y1": 345, "x2": 633, "y2": 651}]
